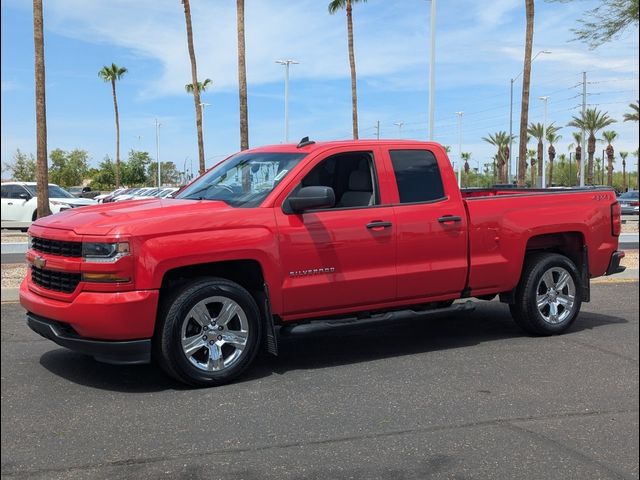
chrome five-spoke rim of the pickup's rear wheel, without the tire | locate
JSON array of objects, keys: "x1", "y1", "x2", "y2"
[{"x1": 536, "y1": 267, "x2": 576, "y2": 325}]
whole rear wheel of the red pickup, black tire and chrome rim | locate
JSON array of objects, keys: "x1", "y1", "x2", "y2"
[{"x1": 509, "y1": 253, "x2": 582, "y2": 336}]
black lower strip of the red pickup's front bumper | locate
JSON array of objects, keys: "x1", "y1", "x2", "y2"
[{"x1": 27, "y1": 312, "x2": 151, "y2": 365}]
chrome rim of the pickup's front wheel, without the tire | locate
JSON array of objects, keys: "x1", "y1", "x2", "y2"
[{"x1": 181, "y1": 296, "x2": 249, "y2": 372}]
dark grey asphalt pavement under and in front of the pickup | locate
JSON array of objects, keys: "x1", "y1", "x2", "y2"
[{"x1": 1, "y1": 282, "x2": 639, "y2": 480}]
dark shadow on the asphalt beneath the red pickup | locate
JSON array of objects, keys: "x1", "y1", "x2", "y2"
[{"x1": 40, "y1": 302, "x2": 628, "y2": 393}]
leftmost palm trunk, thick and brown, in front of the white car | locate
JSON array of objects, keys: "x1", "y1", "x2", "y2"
[{"x1": 33, "y1": 0, "x2": 51, "y2": 218}]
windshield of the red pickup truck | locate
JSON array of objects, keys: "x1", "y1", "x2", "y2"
[{"x1": 176, "y1": 152, "x2": 306, "y2": 207}]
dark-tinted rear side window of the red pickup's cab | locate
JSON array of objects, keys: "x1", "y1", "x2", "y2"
[{"x1": 389, "y1": 150, "x2": 444, "y2": 203}]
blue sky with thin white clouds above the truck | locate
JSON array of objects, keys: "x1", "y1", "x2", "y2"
[{"x1": 0, "y1": 0, "x2": 640, "y2": 178}]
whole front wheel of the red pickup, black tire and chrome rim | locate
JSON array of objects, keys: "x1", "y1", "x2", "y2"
[{"x1": 154, "y1": 277, "x2": 262, "y2": 387}]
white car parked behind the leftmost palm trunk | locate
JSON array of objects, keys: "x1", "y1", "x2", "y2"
[{"x1": 0, "y1": 182, "x2": 97, "y2": 222}]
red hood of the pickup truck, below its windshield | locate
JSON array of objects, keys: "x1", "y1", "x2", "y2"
[{"x1": 34, "y1": 198, "x2": 240, "y2": 236}]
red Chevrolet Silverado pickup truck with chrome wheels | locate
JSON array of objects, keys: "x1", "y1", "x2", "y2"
[{"x1": 20, "y1": 139, "x2": 624, "y2": 386}]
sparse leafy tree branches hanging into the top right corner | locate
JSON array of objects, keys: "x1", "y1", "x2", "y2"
[{"x1": 556, "y1": 0, "x2": 639, "y2": 49}]
